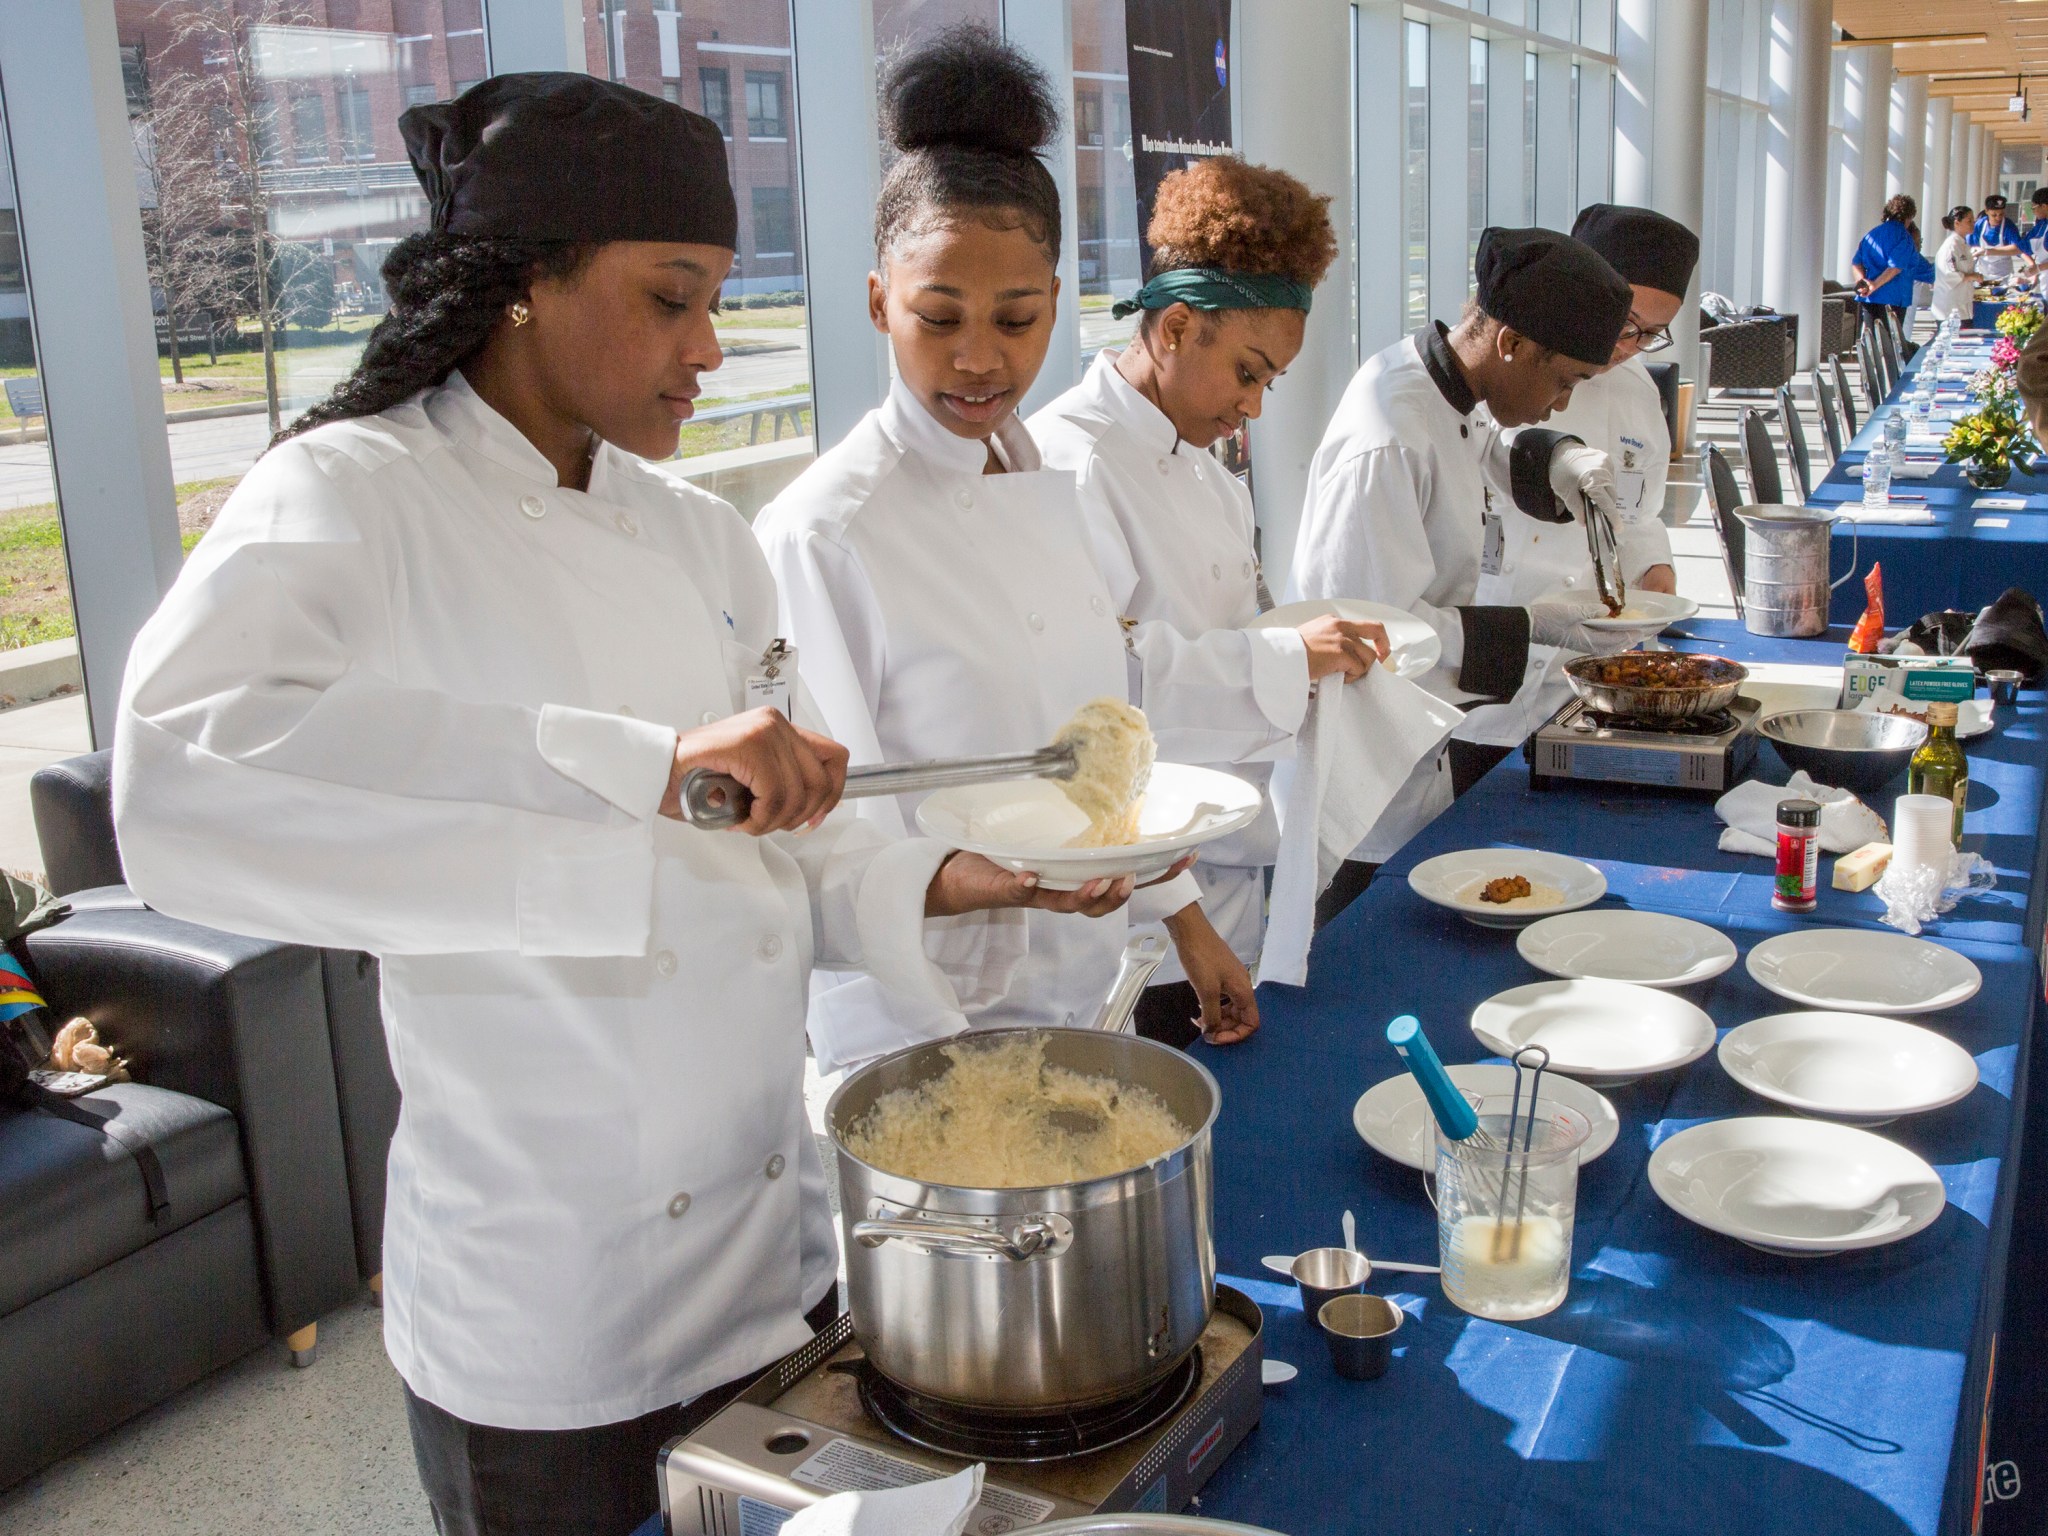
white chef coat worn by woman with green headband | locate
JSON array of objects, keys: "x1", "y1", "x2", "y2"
[{"x1": 1030, "y1": 348, "x2": 1309, "y2": 981}]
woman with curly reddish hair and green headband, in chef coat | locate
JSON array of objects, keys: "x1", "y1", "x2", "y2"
[{"x1": 1030, "y1": 156, "x2": 1337, "y2": 1032}]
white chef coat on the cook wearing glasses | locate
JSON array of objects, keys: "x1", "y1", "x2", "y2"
[{"x1": 1479, "y1": 356, "x2": 1671, "y2": 604}]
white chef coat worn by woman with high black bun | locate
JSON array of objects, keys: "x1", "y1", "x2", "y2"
[{"x1": 754, "y1": 383, "x2": 1305, "y2": 1069}]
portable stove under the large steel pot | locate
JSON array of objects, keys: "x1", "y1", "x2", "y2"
[{"x1": 662, "y1": 1286, "x2": 1264, "y2": 1536}]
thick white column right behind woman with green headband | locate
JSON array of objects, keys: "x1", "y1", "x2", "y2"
[{"x1": 1235, "y1": 0, "x2": 1351, "y2": 592}]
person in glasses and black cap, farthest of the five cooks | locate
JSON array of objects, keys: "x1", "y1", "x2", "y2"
[{"x1": 1487, "y1": 203, "x2": 1700, "y2": 602}]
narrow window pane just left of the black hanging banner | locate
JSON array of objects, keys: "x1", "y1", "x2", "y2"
[{"x1": 1073, "y1": 0, "x2": 1145, "y2": 360}]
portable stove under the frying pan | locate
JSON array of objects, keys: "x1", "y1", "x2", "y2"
[{"x1": 1522, "y1": 694, "x2": 1757, "y2": 795}]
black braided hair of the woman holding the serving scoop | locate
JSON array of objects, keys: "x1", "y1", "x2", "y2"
[{"x1": 270, "y1": 233, "x2": 592, "y2": 446}]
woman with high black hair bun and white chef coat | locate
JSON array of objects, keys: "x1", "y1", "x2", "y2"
[{"x1": 754, "y1": 39, "x2": 1374, "y2": 1069}]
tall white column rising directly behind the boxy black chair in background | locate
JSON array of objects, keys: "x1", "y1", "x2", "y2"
[{"x1": 1761, "y1": 0, "x2": 1831, "y2": 369}]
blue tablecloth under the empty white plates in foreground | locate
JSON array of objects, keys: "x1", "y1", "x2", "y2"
[{"x1": 1202, "y1": 623, "x2": 2048, "y2": 1536}]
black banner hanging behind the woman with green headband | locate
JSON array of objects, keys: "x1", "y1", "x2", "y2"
[{"x1": 1124, "y1": 0, "x2": 1233, "y2": 272}]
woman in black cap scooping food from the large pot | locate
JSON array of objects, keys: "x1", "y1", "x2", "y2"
[{"x1": 115, "y1": 74, "x2": 1122, "y2": 1536}]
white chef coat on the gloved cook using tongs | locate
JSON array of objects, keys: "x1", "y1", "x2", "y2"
[{"x1": 1288, "y1": 332, "x2": 1567, "y2": 745}]
